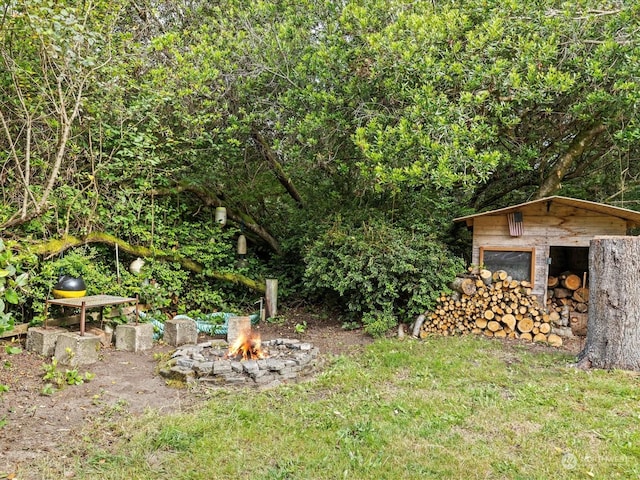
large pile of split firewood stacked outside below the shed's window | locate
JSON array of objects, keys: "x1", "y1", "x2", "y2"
[{"x1": 420, "y1": 268, "x2": 562, "y2": 346}]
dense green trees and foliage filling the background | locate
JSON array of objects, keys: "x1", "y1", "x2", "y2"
[{"x1": 0, "y1": 0, "x2": 640, "y2": 333}]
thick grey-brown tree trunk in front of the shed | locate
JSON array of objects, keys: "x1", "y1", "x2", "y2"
[{"x1": 578, "y1": 236, "x2": 640, "y2": 370}]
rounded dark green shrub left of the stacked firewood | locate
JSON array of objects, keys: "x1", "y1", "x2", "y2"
[{"x1": 304, "y1": 219, "x2": 463, "y2": 336}]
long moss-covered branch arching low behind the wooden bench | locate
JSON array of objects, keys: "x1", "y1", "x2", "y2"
[{"x1": 28, "y1": 232, "x2": 265, "y2": 293}]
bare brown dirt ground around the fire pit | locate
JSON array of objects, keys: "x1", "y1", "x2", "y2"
[{"x1": 0, "y1": 312, "x2": 372, "y2": 474}]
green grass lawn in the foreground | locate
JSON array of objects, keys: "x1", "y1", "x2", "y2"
[{"x1": 33, "y1": 337, "x2": 640, "y2": 480}]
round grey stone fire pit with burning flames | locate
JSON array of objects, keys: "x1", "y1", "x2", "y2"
[{"x1": 160, "y1": 331, "x2": 319, "y2": 388}]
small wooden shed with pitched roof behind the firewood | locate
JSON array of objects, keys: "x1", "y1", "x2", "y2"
[{"x1": 454, "y1": 196, "x2": 640, "y2": 300}]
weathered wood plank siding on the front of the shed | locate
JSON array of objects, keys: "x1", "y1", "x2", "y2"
[{"x1": 472, "y1": 204, "x2": 627, "y2": 296}]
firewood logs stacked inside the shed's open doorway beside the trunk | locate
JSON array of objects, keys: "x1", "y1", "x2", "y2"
[{"x1": 547, "y1": 272, "x2": 589, "y2": 336}]
